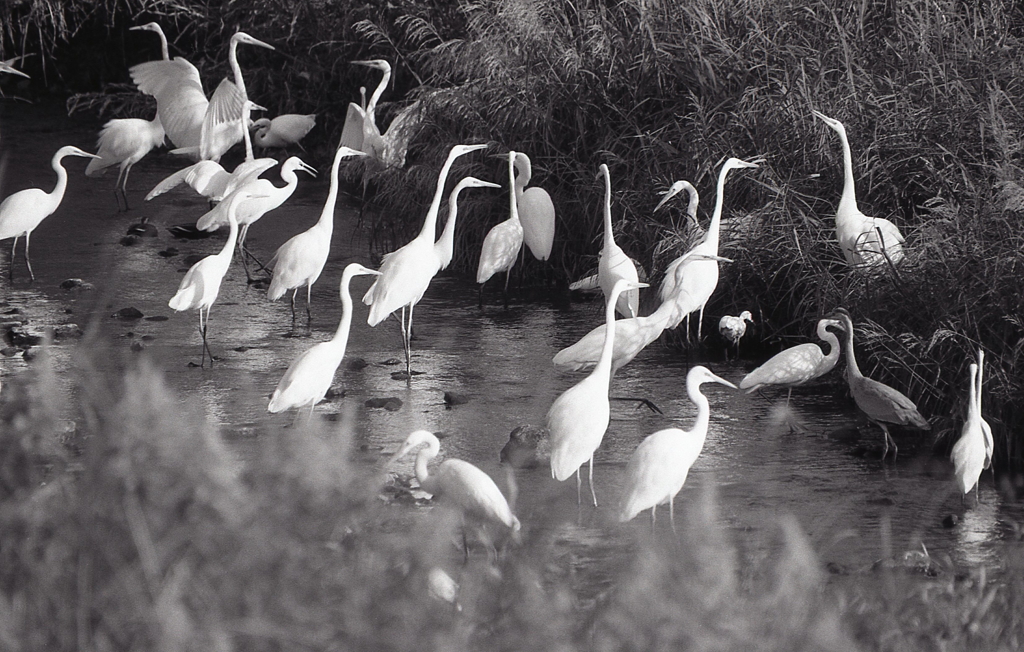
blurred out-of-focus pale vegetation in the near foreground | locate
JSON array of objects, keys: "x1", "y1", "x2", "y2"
[{"x1": 0, "y1": 354, "x2": 1024, "y2": 652}]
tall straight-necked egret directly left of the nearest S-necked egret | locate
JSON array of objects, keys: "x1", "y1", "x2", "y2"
[{"x1": 547, "y1": 278, "x2": 647, "y2": 507}]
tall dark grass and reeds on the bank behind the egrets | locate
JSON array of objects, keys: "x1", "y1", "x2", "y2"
[{"x1": 0, "y1": 0, "x2": 1024, "y2": 468}]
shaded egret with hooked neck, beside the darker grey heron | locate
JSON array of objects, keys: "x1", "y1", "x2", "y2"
[{"x1": 739, "y1": 318, "x2": 843, "y2": 404}]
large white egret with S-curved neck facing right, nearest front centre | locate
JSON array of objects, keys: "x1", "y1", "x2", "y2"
[{"x1": 618, "y1": 365, "x2": 736, "y2": 531}]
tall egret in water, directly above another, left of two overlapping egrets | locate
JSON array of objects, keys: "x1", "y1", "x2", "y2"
[{"x1": 266, "y1": 146, "x2": 367, "y2": 321}]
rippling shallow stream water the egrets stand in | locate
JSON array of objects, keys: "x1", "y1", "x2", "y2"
[{"x1": 0, "y1": 102, "x2": 1024, "y2": 583}]
